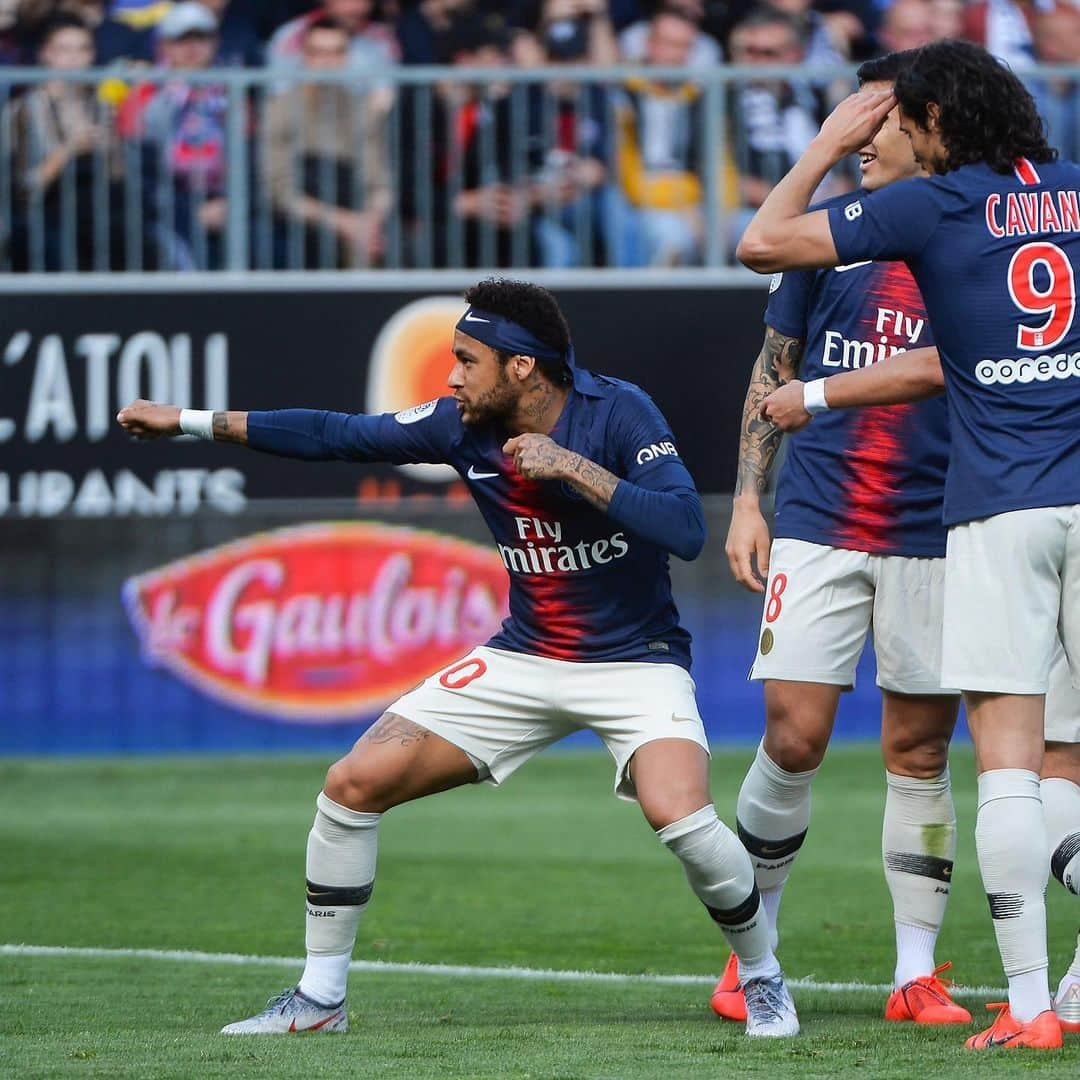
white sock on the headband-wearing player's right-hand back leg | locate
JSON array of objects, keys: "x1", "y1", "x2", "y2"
[{"x1": 657, "y1": 806, "x2": 780, "y2": 981}]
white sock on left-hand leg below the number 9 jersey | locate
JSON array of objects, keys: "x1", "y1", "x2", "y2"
[{"x1": 975, "y1": 769, "x2": 1050, "y2": 1023}]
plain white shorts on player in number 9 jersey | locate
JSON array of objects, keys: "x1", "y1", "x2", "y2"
[{"x1": 942, "y1": 504, "x2": 1080, "y2": 693}]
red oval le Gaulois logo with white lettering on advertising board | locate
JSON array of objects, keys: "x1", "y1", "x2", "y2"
[{"x1": 124, "y1": 523, "x2": 508, "y2": 723}]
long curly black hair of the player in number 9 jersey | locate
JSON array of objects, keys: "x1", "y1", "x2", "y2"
[{"x1": 896, "y1": 41, "x2": 1057, "y2": 174}]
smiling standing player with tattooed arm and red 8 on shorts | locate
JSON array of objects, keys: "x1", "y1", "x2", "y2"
[{"x1": 712, "y1": 53, "x2": 971, "y2": 1024}]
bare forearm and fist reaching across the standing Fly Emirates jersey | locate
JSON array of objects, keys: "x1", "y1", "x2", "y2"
[{"x1": 760, "y1": 348, "x2": 945, "y2": 431}]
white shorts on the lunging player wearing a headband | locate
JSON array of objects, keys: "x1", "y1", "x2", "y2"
[{"x1": 387, "y1": 646, "x2": 708, "y2": 799}]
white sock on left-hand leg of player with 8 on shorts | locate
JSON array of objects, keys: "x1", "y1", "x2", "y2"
[{"x1": 735, "y1": 741, "x2": 818, "y2": 911}]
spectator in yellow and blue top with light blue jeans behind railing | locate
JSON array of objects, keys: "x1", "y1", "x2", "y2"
[{"x1": 616, "y1": 8, "x2": 703, "y2": 266}]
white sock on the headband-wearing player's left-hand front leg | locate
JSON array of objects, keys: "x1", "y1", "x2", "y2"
[{"x1": 300, "y1": 792, "x2": 381, "y2": 1005}]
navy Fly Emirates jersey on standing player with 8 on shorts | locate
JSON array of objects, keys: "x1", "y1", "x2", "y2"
[{"x1": 765, "y1": 194, "x2": 948, "y2": 557}]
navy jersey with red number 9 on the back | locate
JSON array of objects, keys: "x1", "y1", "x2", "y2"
[{"x1": 828, "y1": 159, "x2": 1080, "y2": 525}]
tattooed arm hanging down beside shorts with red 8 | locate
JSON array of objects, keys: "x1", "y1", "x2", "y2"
[{"x1": 724, "y1": 326, "x2": 804, "y2": 593}]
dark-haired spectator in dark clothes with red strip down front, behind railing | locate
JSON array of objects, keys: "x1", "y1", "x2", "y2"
[{"x1": 400, "y1": 17, "x2": 543, "y2": 267}]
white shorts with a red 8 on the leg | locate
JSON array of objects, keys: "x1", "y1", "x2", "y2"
[{"x1": 750, "y1": 538, "x2": 955, "y2": 694}]
